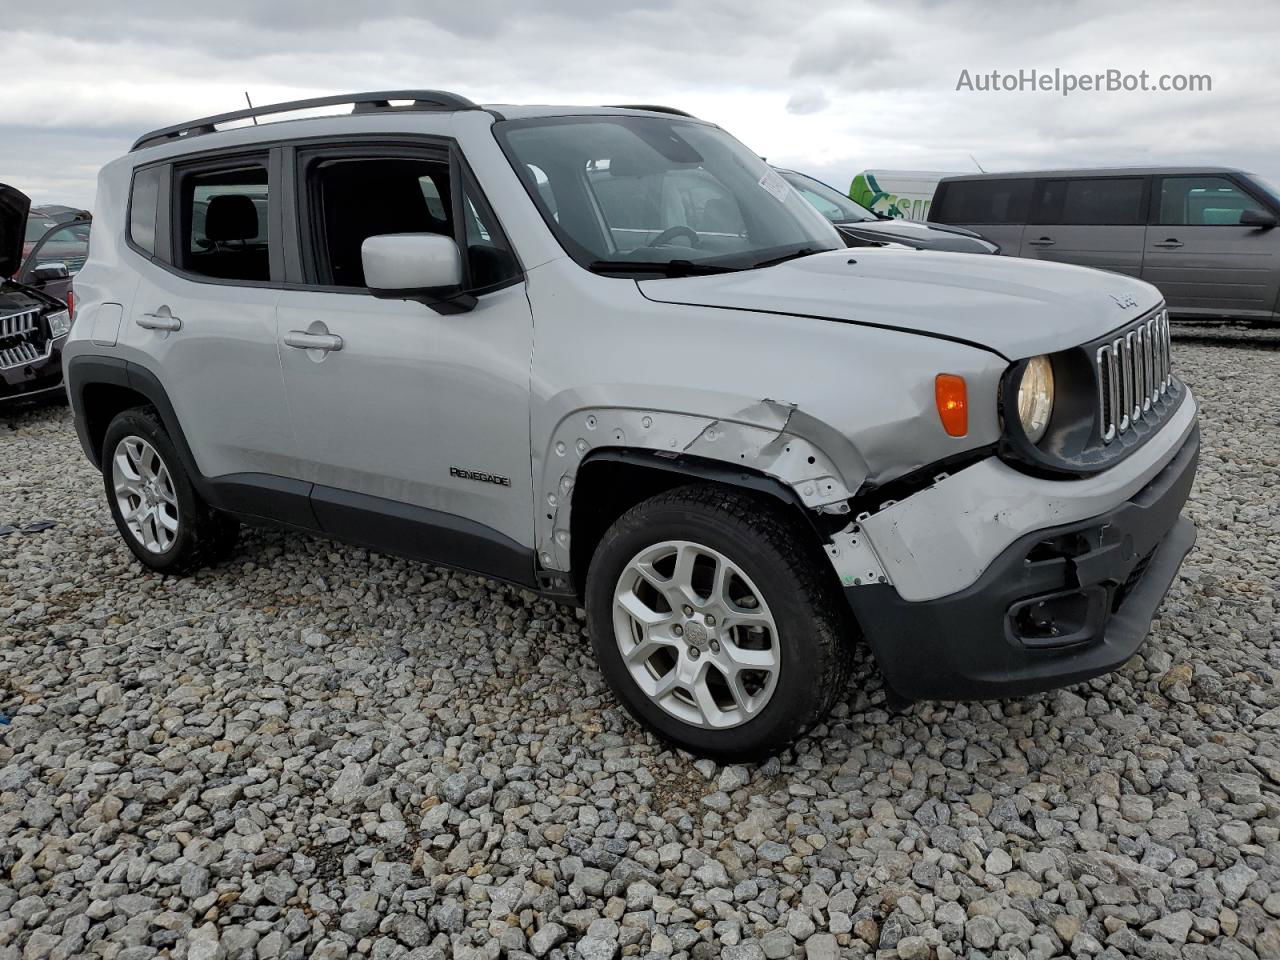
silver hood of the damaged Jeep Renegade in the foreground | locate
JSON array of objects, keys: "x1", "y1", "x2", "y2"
[{"x1": 639, "y1": 247, "x2": 1160, "y2": 360}]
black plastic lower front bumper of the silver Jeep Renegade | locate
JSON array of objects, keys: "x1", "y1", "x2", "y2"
[{"x1": 845, "y1": 428, "x2": 1199, "y2": 700}]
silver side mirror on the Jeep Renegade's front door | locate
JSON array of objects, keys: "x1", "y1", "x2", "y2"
[{"x1": 360, "y1": 233, "x2": 476, "y2": 314}]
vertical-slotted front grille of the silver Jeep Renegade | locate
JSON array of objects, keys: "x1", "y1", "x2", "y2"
[{"x1": 1094, "y1": 310, "x2": 1174, "y2": 443}]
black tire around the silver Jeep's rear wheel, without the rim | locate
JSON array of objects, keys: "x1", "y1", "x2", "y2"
[{"x1": 102, "y1": 407, "x2": 239, "y2": 576}]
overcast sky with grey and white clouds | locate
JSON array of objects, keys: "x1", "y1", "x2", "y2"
[{"x1": 0, "y1": 0, "x2": 1280, "y2": 206}]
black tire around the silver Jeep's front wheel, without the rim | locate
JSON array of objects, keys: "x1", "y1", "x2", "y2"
[{"x1": 586, "y1": 485, "x2": 855, "y2": 760}]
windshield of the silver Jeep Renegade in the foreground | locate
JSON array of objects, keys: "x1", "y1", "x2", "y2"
[{"x1": 494, "y1": 115, "x2": 845, "y2": 274}]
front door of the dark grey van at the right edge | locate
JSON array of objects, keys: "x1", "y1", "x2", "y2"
[{"x1": 1142, "y1": 174, "x2": 1280, "y2": 317}]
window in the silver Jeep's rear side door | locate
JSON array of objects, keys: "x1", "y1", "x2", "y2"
[{"x1": 177, "y1": 163, "x2": 271, "y2": 280}]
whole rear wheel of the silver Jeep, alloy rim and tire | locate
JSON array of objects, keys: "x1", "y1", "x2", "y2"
[{"x1": 102, "y1": 407, "x2": 239, "y2": 575}]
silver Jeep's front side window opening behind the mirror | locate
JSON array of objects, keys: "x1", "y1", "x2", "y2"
[{"x1": 305, "y1": 155, "x2": 518, "y2": 289}]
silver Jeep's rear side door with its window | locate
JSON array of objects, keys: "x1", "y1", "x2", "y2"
[{"x1": 119, "y1": 156, "x2": 295, "y2": 488}]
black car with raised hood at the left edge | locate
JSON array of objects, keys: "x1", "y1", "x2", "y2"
[{"x1": 0, "y1": 183, "x2": 74, "y2": 404}]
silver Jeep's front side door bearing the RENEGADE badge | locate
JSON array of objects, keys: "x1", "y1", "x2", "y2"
[{"x1": 278, "y1": 146, "x2": 532, "y2": 581}]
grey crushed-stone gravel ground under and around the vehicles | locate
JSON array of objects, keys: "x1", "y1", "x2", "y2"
[{"x1": 0, "y1": 344, "x2": 1280, "y2": 960}]
